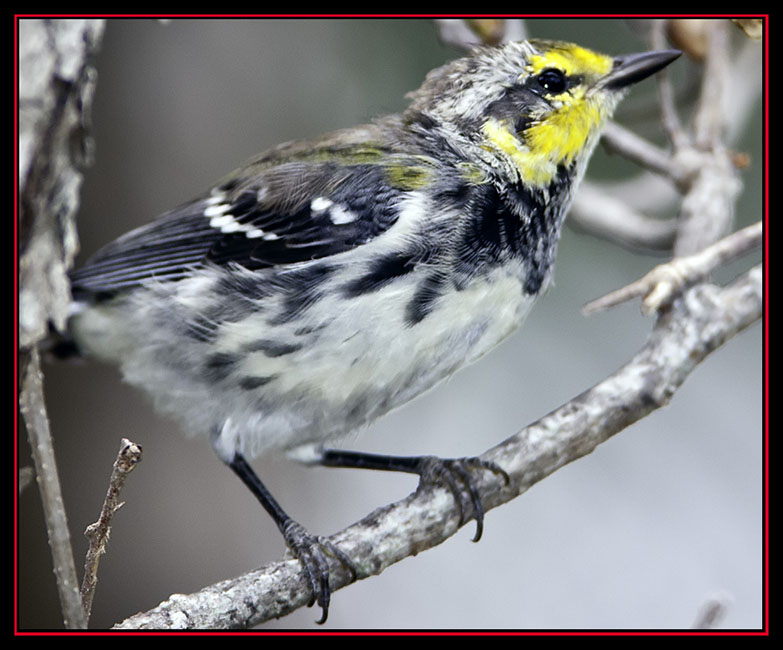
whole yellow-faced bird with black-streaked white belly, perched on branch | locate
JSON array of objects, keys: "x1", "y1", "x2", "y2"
[{"x1": 61, "y1": 39, "x2": 680, "y2": 623}]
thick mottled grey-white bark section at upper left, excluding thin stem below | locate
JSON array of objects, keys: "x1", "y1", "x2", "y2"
[{"x1": 18, "y1": 19, "x2": 104, "y2": 347}]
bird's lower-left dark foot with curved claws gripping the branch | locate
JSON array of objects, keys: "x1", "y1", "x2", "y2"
[{"x1": 282, "y1": 519, "x2": 356, "y2": 625}]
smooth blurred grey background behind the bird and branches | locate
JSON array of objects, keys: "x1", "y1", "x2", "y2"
[{"x1": 18, "y1": 19, "x2": 763, "y2": 629}]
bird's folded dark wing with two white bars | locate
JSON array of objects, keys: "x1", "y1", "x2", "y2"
[{"x1": 71, "y1": 149, "x2": 423, "y2": 294}]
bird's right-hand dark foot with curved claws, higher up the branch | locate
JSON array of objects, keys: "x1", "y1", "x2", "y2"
[{"x1": 420, "y1": 456, "x2": 511, "y2": 542}]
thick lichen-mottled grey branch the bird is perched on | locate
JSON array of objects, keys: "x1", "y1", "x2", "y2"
[{"x1": 116, "y1": 267, "x2": 763, "y2": 629}]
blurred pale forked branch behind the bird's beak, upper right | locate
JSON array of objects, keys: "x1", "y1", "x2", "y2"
[{"x1": 571, "y1": 20, "x2": 761, "y2": 257}]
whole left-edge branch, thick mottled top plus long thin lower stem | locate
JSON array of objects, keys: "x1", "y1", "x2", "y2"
[{"x1": 17, "y1": 19, "x2": 104, "y2": 628}]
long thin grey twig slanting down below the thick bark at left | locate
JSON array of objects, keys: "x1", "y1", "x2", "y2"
[{"x1": 19, "y1": 348, "x2": 86, "y2": 629}]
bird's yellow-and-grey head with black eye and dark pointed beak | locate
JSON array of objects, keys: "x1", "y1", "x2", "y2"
[{"x1": 405, "y1": 40, "x2": 680, "y2": 187}]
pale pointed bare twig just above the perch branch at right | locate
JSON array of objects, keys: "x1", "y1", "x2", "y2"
[{"x1": 582, "y1": 221, "x2": 762, "y2": 314}]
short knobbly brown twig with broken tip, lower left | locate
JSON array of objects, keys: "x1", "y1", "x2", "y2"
[{"x1": 81, "y1": 438, "x2": 141, "y2": 623}]
